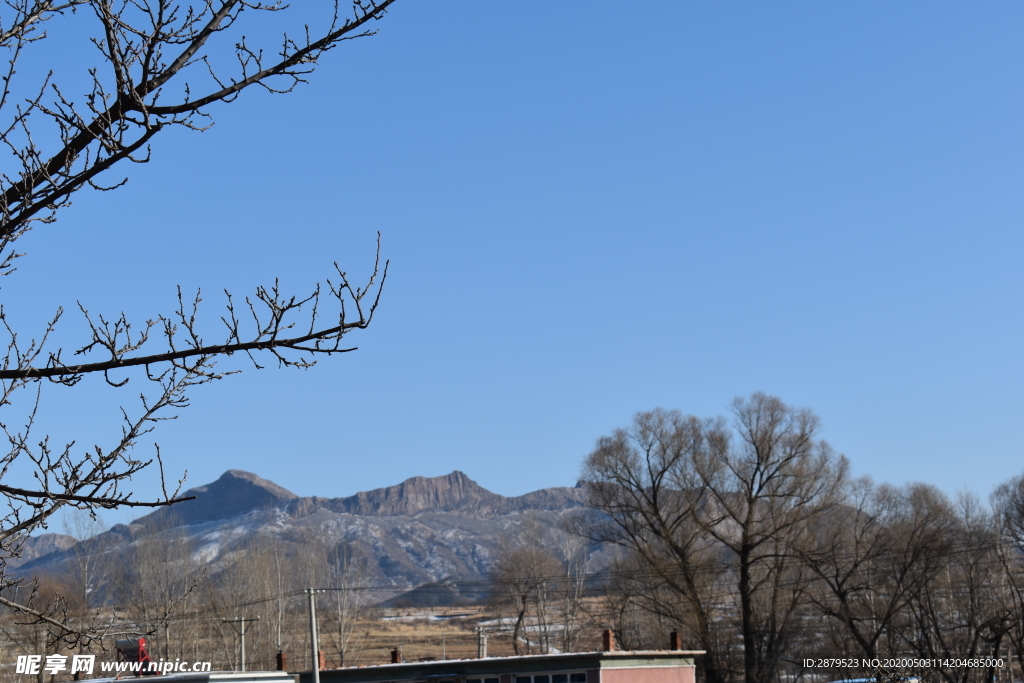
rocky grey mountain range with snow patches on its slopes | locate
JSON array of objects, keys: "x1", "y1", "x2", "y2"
[{"x1": 12, "y1": 470, "x2": 598, "y2": 603}]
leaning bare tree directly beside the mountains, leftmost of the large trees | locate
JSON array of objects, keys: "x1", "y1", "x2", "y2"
[{"x1": 577, "y1": 410, "x2": 731, "y2": 683}]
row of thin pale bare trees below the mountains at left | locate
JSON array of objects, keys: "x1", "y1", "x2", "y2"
[{"x1": 0, "y1": 519, "x2": 376, "y2": 680}]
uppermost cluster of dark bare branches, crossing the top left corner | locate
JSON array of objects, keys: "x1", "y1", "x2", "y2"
[{"x1": 0, "y1": 0, "x2": 393, "y2": 240}]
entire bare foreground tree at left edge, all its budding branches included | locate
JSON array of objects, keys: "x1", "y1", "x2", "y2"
[{"x1": 0, "y1": 0, "x2": 393, "y2": 642}]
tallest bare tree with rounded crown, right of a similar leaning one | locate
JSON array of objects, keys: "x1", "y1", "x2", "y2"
[{"x1": 683, "y1": 393, "x2": 847, "y2": 683}]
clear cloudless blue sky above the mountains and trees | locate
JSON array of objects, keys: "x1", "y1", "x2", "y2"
[{"x1": 3, "y1": 0, "x2": 1024, "y2": 511}]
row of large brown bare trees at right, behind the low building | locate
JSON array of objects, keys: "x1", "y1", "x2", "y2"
[{"x1": 575, "y1": 394, "x2": 1024, "y2": 683}]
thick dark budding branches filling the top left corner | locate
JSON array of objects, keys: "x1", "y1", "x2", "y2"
[{"x1": 0, "y1": 0, "x2": 394, "y2": 244}]
